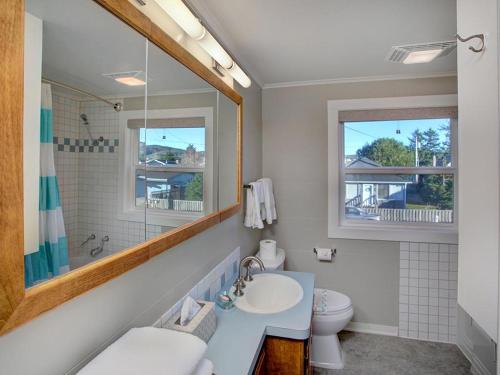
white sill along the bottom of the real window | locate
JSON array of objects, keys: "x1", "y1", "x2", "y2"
[{"x1": 328, "y1": 223, "x2": 458, "y2": 244}]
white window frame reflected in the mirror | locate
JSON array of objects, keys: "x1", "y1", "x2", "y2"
[{"x1": 118, "y1": 107, "x2": 214, "y2": 227}]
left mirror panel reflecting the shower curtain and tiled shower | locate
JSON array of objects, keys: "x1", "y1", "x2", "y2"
[{"x1": 23, "y1": 0, "x2": 147, "y2": 287}]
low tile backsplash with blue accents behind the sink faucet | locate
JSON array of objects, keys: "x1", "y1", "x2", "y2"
[{"x1": 153, "y1": 247, "x2": 240, "y2": 327}]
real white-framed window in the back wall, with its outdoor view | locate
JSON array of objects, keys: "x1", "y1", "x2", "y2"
[{"x1": 329, "y1": 96, "x2": 457, "y2": 244}]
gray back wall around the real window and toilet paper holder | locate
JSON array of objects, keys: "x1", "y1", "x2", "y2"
[{"x1": 262, "y1": 77, "x2": 457, "y2": 326}]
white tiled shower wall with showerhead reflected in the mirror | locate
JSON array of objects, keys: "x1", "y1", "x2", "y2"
[{"x1": 53, "y1": 91, "x2": 165, "y2": 269}]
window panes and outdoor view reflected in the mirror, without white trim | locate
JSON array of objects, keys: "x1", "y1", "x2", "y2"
[{"x1": 134, "y1": 126, "x2": 206, "y2": 213}]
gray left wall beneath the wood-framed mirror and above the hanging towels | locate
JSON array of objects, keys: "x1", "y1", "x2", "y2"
[{"x1": 0, "y1": 83, "x2": 262, "y2": 375}]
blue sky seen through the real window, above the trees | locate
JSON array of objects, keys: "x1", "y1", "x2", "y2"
[{"x1": 344, "y1": 119, "x2": 450, "y2": 155}]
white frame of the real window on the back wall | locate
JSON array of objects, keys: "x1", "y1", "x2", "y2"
[{"x1": 328, "y1": 95, "x2": 458, "y2": 244}]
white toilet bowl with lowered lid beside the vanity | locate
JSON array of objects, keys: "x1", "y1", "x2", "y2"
[{"x1": 311, "y1": 289, "x2": 354, "y2": 369}]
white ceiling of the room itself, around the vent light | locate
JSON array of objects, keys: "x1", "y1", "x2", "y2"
[{"x1": 189, "y1": 0, "x2": 456, "y2": 85}]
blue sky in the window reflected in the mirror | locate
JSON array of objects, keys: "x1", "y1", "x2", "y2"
[{"x1": 140, "y1": 128, "x2": 205, "y2": 151}]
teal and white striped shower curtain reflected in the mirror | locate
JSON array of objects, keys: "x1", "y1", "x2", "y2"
[{"x1": 24, "y1": 84, "x2": 69, "y2": 288}]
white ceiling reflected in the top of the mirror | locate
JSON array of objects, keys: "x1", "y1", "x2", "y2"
[{"x1": 26, "y1": 0, "x2": 211, "y2": 96}]
